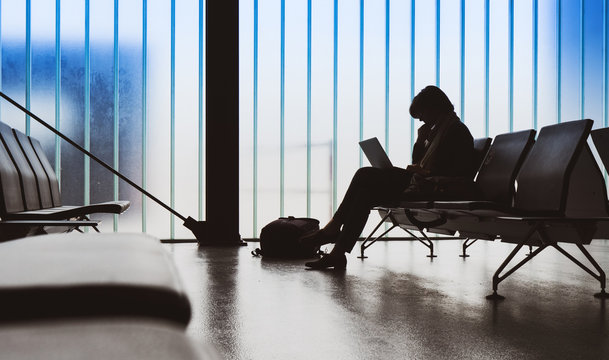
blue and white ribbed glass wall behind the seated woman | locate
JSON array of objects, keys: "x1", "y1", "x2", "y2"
[{"x1": 0, "y1": 0, "x2": 609, "y2": 242}]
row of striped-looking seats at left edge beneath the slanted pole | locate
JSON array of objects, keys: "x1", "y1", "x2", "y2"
[{"x1": 0, "y1": 123, "x2": 130, "y2": 240}]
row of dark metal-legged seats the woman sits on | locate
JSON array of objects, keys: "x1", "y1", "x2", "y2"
[{"x1": 361, "y1": 120, "x2": 609, "y2": 299}]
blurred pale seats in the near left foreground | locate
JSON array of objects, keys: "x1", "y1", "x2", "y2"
[{"x1": 0, "y1": 233, "x2": 219, "y2": 360}]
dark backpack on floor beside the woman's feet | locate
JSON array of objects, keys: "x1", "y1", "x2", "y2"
[{"x1": 252, "y1": 216, "x2": 319, "y2": 259}]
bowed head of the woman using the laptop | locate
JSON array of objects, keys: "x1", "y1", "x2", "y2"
[{"x1": 410, "y1": 85, "x2": 455, "y2": 123}]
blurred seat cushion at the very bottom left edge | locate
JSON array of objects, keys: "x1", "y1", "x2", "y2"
[{"x1": 0, "y1": 319, "x2": 221, "y2": 360}]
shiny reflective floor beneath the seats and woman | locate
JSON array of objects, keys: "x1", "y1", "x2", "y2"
[{"x1": 166, "y1": 240, "x2": 609, "y2": 360}]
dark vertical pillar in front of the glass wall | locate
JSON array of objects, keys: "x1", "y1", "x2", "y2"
[{"x1": 204, "y1": 0, "x2": 243, "y2": 245}]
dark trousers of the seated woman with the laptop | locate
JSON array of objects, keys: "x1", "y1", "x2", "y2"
[{"x1": 334, "y1": 167, "x2": 411, "y2": 252}]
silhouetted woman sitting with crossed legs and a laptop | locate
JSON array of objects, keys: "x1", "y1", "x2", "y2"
[{"x1": 301, "y1": 86, "x2": 474, "y2": 269}]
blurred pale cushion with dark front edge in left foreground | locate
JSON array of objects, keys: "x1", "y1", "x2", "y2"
[{"x1": 0, "y1": 233, "x2": 191, "y2": 326}]
